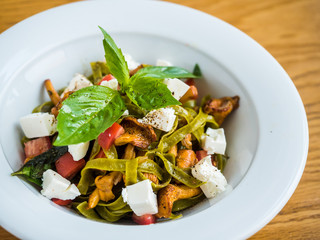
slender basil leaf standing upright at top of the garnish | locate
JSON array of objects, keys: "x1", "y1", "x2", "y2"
[{"x1": 99, "y1": 27, "x2": 130, "y2": 85}]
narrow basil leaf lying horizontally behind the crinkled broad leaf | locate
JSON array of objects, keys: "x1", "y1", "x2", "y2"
[{"x1": 132, "y1": 66, "x2": 198, "y2": 79}]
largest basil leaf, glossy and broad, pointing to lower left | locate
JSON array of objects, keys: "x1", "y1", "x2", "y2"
[{"x1": 54, "y1": 86, "x2": 125, "y2": 146}]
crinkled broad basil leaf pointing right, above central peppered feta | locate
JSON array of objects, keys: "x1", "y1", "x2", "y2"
[{"x1": 126, "y1": 76, "x2": 181, "y2": 111}]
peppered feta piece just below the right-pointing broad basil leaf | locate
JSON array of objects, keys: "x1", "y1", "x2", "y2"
[{"x1": 138, "y1": 108, "x2": 176, "y2": 132}]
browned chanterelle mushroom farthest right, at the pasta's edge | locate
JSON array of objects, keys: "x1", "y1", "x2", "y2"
[{"x1": 203, "y1": 96, "x2": 240, "y2": 125}]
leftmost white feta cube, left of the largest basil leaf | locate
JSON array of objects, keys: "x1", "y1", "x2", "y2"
[{"x1": 20, "y1": 113, "x2": 57, "y2": 138}]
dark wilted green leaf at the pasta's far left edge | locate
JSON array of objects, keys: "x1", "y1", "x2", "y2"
[{"x1": 11, "y1": 146, "x2": 68, "y2": 186}]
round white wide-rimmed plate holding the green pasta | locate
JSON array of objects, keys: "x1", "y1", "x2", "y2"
[{"x1": 0, "y1": 1, "x2": 308, "y2": 239}]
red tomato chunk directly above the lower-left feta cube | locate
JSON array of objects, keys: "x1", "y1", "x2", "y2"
[{"x1": 56, "y1": 152, "x2": 86, "y2": 179}]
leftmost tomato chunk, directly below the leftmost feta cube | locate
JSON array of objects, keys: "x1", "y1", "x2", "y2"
[{"x1": 24, "y1": 137, "x2": 52, "y2": 158}]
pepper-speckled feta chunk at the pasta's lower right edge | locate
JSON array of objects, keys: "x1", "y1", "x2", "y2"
[{"x1": 191, "y1": 156, "x2": 228, "y2": 198}]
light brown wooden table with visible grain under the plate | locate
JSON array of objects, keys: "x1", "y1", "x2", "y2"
[{"x1": 0, "y1": 0, "x2": 320, "y2": 240}]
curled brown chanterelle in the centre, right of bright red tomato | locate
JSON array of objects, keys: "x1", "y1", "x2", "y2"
[{"x1": 114, "y1": 117, "x2": 157, "y2": 149}]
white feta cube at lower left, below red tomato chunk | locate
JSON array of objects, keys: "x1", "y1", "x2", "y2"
[{"x1": 41, "y1": 169, "x2": 80, "y2": 200}]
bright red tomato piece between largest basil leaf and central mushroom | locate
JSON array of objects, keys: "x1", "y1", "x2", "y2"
[{"x1": 98, "y1": 123, "x2": 124, "y2": 150}]
